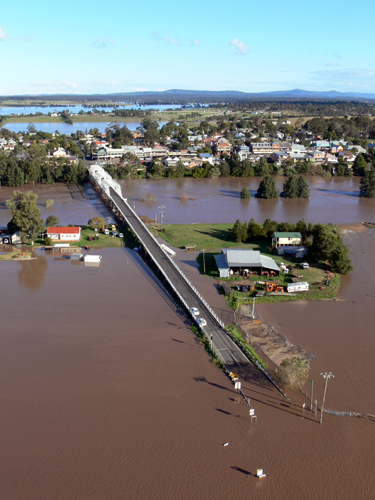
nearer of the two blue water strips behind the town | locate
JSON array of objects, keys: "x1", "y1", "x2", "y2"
[{"x1": 0, "y1": 118, "x2": 166, "y2": 135}]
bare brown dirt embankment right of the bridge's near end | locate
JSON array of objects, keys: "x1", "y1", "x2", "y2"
[{"x1": 237, "y1": 305, "x2": 316, "y2": 366}]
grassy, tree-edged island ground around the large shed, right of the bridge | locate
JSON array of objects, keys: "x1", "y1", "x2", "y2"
[{"x1": 153, "y1": 221, "x2": 351, "y2": 309}]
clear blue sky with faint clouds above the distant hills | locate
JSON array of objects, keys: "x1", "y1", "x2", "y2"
[{"x1": 0, "y1": 0, "x2": 375, "y2": 95}]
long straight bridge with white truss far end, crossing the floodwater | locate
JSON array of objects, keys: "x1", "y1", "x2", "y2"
[{"x1": 89, "y1": 165, "x2": 250, "y2": 367}]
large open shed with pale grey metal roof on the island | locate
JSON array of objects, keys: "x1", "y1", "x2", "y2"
[{"x1": 215, "y1": 248, "x2": 280, "y2": 278}]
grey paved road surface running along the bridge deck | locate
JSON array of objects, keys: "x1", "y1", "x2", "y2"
[{"x1": 110, "y1": 188, "x2": 250, "y2": 367}]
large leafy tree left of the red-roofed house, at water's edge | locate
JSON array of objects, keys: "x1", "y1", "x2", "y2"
[{"x1": 6, "y1": 191, "x2": 45, "y2": 240}]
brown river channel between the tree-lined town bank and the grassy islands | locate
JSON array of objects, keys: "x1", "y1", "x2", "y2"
[{"x1": 0, "y1": 176, "x2": 375, "y2": 228}]
